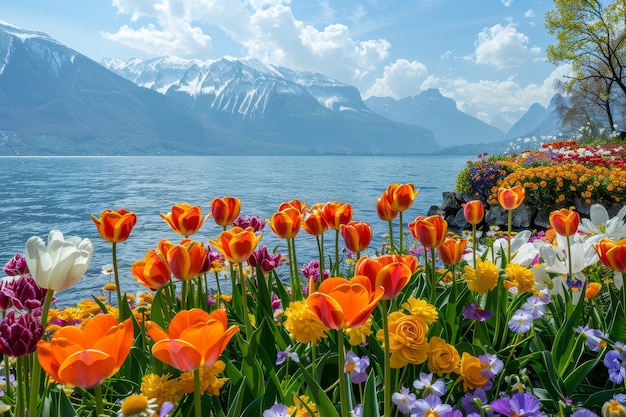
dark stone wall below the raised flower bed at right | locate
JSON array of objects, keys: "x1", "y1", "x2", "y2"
[{"x1": 428, "y1": 192, "x2": 624, "y2": 231}]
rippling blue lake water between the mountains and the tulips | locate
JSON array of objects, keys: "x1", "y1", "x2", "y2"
[{"x1": 0, "y1": 156, "x2": 468, "y2": 305}]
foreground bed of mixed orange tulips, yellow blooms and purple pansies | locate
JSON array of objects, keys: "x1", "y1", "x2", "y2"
[{"x1": 0, "y1": 153, "x2": 626, "y2": 417}]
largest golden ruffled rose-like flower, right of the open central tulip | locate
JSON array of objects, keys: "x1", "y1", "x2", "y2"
[{"x1": 376, "y1": 311, "x2": 429, "y2": 368}]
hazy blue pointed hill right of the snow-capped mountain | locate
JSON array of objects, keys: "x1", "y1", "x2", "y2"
[{"x1": 365, "y1": 89, "x2": 504, "y2": 147}]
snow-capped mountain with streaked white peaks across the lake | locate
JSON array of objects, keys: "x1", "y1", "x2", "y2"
[{"x1": 102, "y1": 57, "x2": 439, "y2": 153}]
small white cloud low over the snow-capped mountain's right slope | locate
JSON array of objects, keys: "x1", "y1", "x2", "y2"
[{"x1": 364, "y1": 59, "x2": 428, "y2": 99}]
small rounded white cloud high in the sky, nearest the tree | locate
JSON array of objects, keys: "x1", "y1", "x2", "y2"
[{"x1": 474, "y1": 23, "x2": 539, "y2": 70}]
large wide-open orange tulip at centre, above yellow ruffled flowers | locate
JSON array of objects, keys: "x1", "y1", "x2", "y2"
[{"x1": 305, "y1": 275, "x2": 384, "y2": 329}]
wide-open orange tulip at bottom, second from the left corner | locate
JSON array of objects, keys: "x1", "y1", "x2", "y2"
[{"x1": 146, "y1": 308, "x2": 239, "y2": 372}]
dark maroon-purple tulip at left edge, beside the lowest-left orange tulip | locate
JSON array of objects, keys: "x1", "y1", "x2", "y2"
[{"x1": 0, "y1": 311, "x2": 43, "y2": 357}]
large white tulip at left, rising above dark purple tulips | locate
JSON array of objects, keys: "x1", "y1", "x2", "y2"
[{"x1": 25, "y1": 230, "x2": 93, "y2": 291}]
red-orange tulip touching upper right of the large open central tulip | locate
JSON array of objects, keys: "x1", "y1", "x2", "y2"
[{"x1": 354, "y1": 255, "x2": 417, "y2": 300}]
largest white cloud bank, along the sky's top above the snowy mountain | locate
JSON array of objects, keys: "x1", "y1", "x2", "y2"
[{"x1": 104, "y1": 0, "x2": 391, "y2": 83}]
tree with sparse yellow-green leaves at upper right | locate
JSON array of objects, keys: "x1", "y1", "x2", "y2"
[{"x1": 546, "y1": 0, "x2": 626, "y2": 130}]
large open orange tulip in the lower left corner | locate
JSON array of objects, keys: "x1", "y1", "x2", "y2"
[{"x1": 37, "y1": 314, "x2": 134, "y2": 389}]
